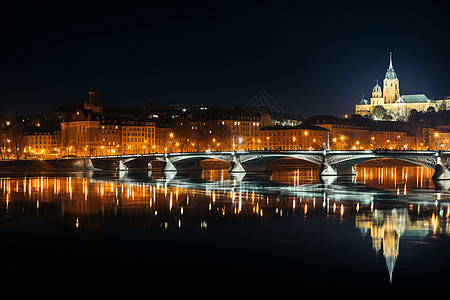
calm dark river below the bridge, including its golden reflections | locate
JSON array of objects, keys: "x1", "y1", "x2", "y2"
[{"x1": 0, "y1": 166, "x2": 450, "y2": 296}]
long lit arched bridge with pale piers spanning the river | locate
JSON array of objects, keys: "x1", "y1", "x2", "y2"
[{"x1": 85, "y1": 150, "x2": 450, "y2": 180}]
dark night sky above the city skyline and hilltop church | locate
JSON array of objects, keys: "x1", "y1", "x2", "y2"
[{"x1": 0, "y1": 0, "x2": 450, "y2": 116}]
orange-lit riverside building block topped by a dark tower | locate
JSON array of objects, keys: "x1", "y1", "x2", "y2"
[{"x1": 61, "y1": 87, "x2": 156, "y2": 156}]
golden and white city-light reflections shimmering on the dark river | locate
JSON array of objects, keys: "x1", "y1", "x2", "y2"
[{"x1": 0, "y1": 167, "x2": 450, "y2": 292}]
